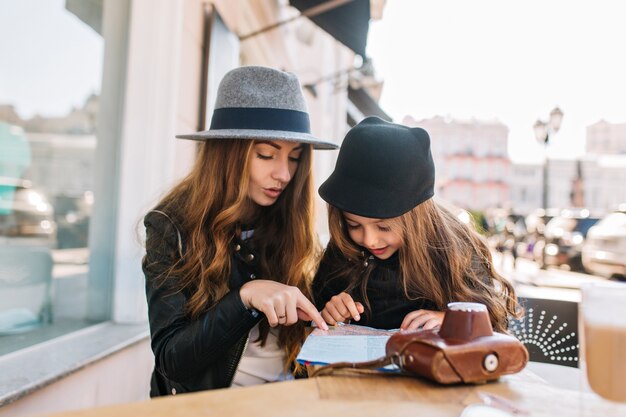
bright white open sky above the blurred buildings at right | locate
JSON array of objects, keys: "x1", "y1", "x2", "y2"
[{"x1": 367, "y1": 0, "x2": 626, "y2": 162}]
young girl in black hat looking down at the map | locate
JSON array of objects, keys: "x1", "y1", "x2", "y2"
[{"x1": 313, "y1": 117, "x2": 517, "y2": 331}]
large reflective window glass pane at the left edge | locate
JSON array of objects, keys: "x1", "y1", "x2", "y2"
[{"x1": 0, "y1": 0, "x2": 104, "y2": 355}]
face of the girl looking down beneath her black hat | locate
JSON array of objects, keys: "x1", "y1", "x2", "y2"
[{"x1": 343, "y1": 211, "x2": 403, "y2": 259}]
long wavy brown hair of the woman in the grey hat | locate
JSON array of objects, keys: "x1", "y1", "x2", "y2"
[{"x1": 151, "y1": 139, "x2": 320, "y2": 369}]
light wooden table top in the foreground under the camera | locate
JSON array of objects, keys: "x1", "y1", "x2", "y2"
[{"x1": 40, "y1": 370, "x2": 626, "y2": 417}]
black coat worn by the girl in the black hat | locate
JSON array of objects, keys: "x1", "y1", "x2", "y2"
[{"x1": 313, "y1": 245, "x2": 438, "y2": 329}]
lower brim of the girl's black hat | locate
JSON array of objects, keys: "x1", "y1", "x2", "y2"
[{"x1": 318, "y1": 174, "x2": 434, "y2": 219}]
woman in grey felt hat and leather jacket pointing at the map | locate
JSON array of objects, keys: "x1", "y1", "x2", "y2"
[{"x1": 143, "y1": 67, "x2": 336, "y2": 396}]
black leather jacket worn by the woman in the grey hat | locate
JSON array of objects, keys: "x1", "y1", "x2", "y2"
[{"x1": 142, "y1": 210, "x2": 264, "y2": 397}]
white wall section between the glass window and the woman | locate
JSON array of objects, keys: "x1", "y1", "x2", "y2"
[{"x1": 112, "y1": 0, "x2": 199, "y2": 323}]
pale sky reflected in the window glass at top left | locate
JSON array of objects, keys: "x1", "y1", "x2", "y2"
[{"x1": 0, "y1": 0, "x2": 104, "y2": 119}]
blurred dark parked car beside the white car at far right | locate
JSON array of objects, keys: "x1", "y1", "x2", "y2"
[{"x1": 541, "y1": 209, "x2": 600, "y2": 271}]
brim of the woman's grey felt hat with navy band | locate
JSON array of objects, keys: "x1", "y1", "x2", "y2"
[{"x1": 176, "y1": 129, "x2": 339, "y2": 150}]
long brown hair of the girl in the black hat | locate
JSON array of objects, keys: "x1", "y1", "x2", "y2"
[{"x1": 328, "y1": 198, "x2": 520, "y2": 332}]
